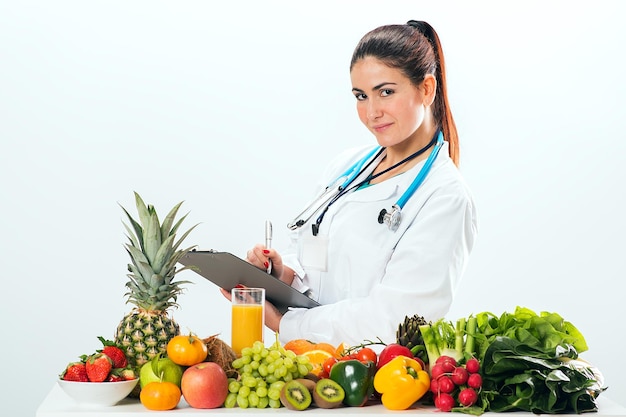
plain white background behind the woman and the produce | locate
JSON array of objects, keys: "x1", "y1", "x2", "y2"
[{"x1": 0, "y1": 0, "x2": 626, "y2": 416}]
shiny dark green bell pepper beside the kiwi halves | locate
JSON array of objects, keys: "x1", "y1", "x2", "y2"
[{"x1": 329, "y1": 359, "x2": 376, "y2": 407}]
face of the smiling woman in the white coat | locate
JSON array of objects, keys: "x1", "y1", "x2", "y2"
[{"x1": 350, "y1": 57, "x2": 434, "y2": 147}]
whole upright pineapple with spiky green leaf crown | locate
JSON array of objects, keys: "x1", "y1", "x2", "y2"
[{"x1": 115, "y1": 193, "x2": 197, "y2": 367}]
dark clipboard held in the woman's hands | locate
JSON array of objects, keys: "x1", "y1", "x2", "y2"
[{"x1": 178, "y1": 250, "x2": 320, "y2": 313}]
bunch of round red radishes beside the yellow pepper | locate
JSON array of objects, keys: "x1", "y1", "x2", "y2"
[{"x1": 430, "y1": 355, "x2": 483, "y2": 411}]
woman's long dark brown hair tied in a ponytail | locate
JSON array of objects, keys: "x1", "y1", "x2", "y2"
[{"x1": 350, "y1": 20, "x2": 459, "y2": 165}]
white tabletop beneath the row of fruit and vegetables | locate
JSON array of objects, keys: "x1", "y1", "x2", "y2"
[{"x1": 37, "y1": 384, "x2": 626, "y2": 417}]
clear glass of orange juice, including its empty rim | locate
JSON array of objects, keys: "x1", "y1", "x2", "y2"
[{"x1": 230, "y1": 287, "x2": 265, "y2": 356}]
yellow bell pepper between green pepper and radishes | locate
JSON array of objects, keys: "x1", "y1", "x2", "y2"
[{"x1": 374, "y1": 356, "x2": 430, "y2": 410}]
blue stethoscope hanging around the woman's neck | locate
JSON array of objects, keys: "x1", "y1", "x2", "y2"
[{"x1": 287, "y1": 131, "x2": 444, "y2": 236}]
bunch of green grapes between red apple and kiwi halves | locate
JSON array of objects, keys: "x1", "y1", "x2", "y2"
[{"x1": 224, "y1": 340, "x2": 313, "y2": 408}]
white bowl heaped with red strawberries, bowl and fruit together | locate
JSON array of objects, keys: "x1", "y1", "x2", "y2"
[{"x1": 58, "y1": 337, "x2": 139, "y2": 407}]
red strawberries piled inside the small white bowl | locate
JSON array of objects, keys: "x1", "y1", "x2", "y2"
[{"x1": 59, "y1": 336, "x2": 137, "y2": 382}]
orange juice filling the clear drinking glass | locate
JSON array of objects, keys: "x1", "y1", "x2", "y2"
[{"x1": 231, "y1": 304, "x2": 263, "y2": 356}]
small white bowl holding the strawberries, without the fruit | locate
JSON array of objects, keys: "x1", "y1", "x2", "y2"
[{"x1": 59, "y1": 378, "x2": 139, "y2": 407}]
